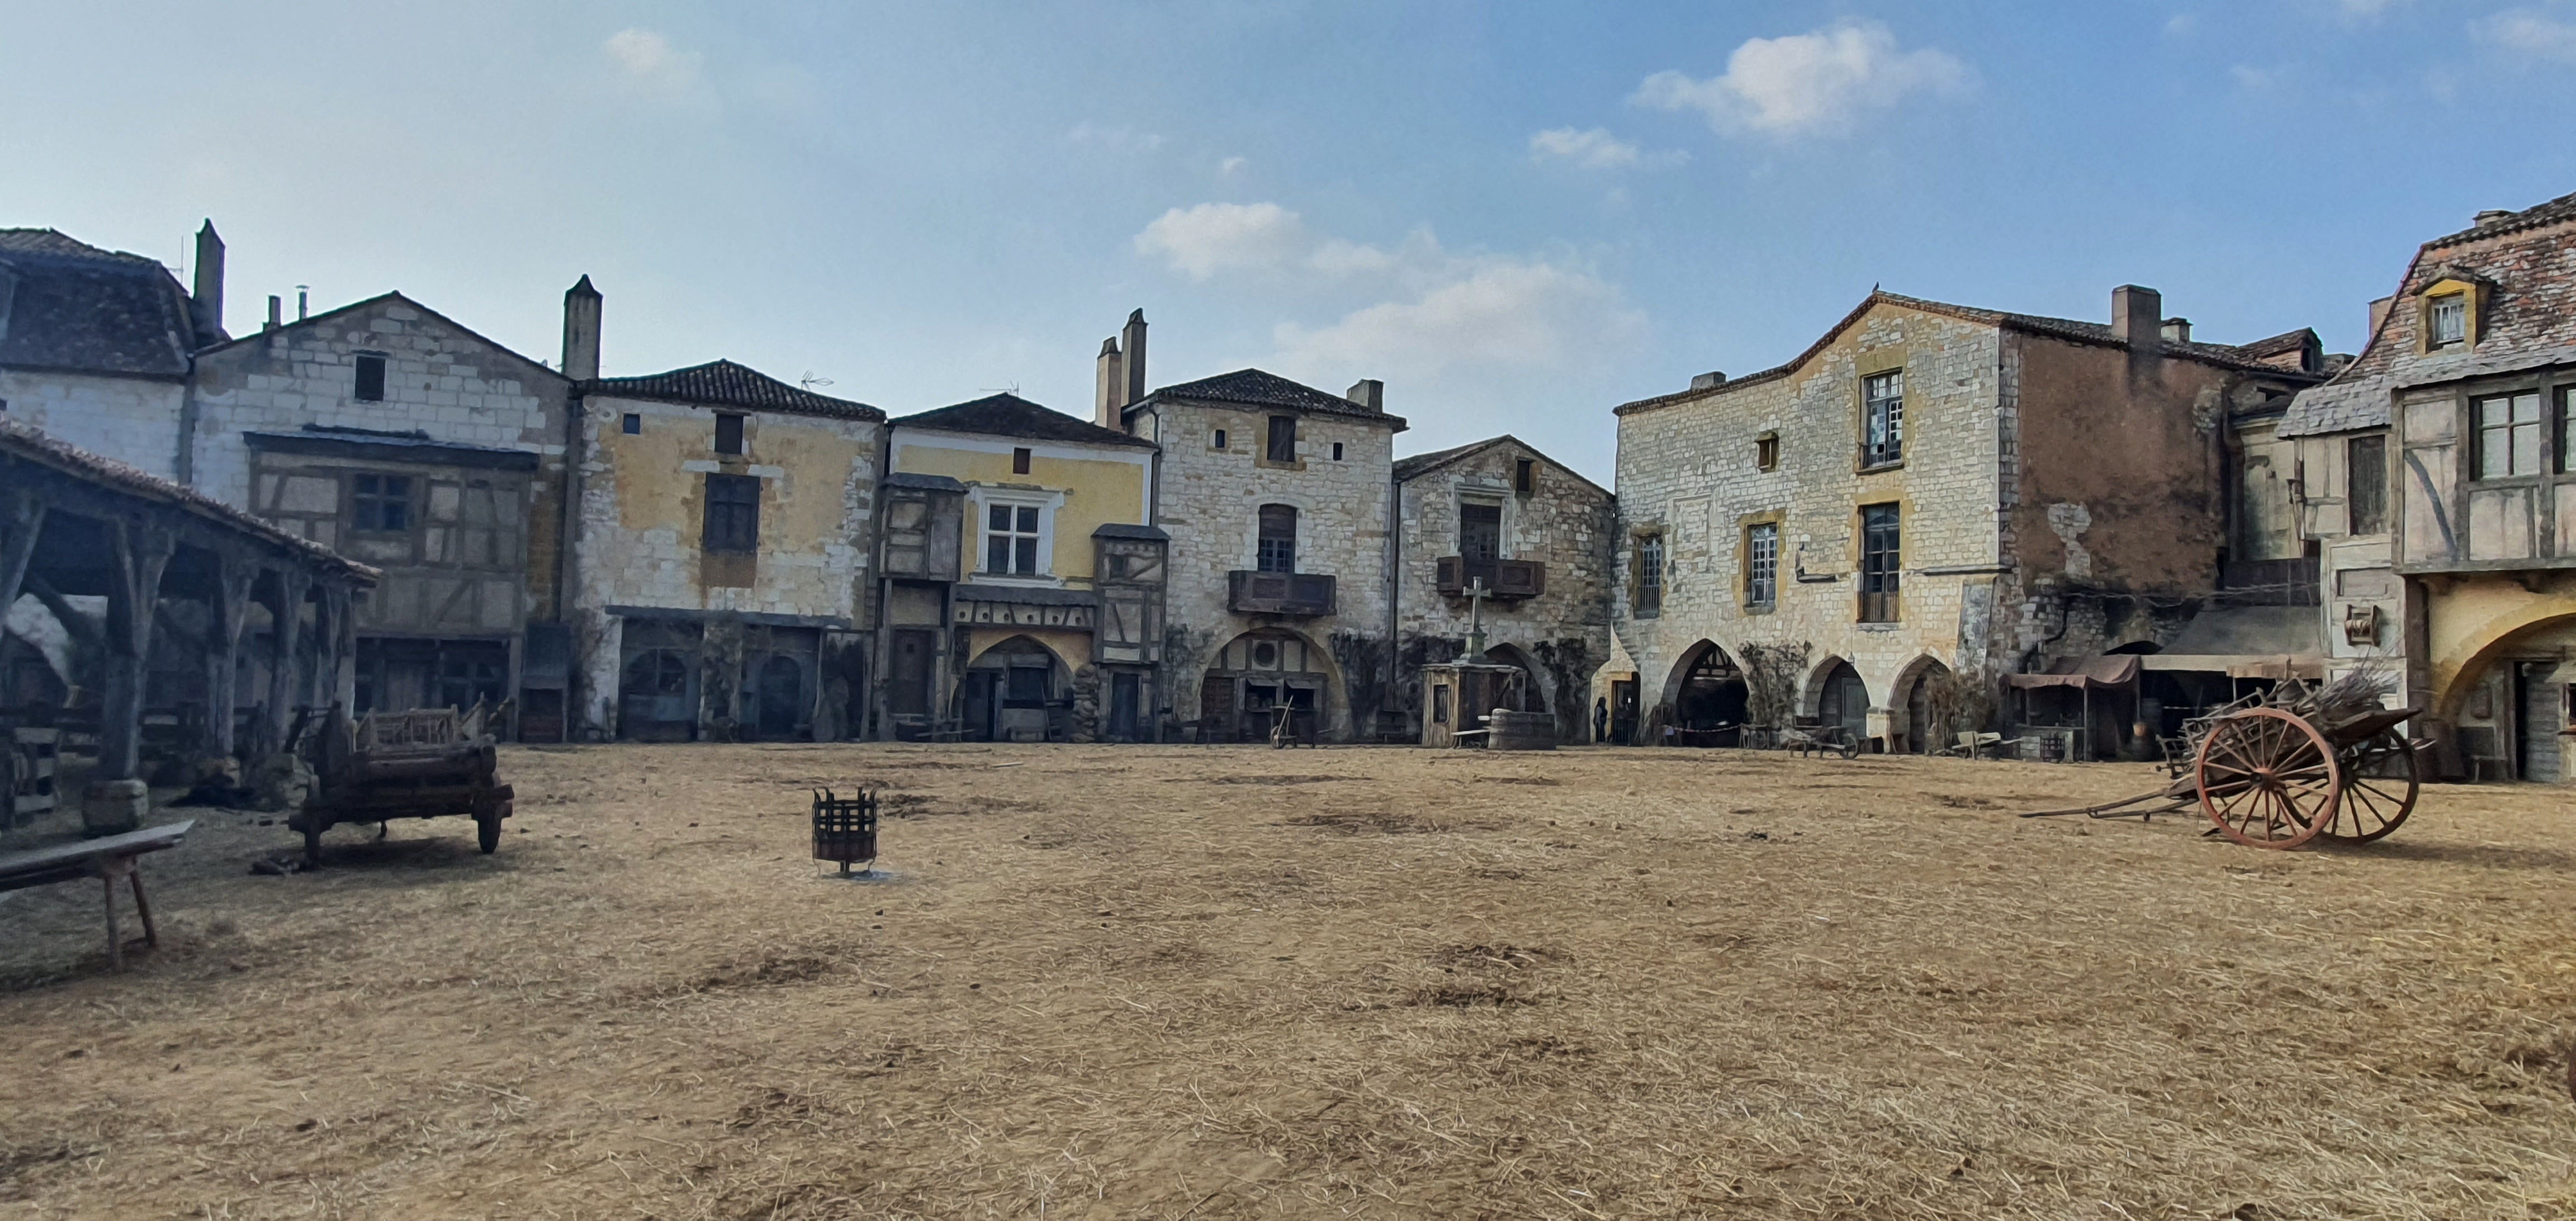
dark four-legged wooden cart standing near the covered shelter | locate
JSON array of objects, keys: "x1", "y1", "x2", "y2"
[{"x1": 286, "y1": 703, "x2": 518, "y2": 865}]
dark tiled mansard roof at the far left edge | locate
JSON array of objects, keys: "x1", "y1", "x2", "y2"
[{"x1": 0, "y1": 229, "x2": 221, "y2": 378}]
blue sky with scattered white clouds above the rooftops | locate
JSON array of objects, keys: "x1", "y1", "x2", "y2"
[{"x1": 0, "y1": 0, "x2": 2576, "y2": 482}]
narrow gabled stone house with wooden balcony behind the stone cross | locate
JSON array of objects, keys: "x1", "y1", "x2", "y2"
[{"x1": 1391, "y1": 436, "x2": 1618, "y2": 742}]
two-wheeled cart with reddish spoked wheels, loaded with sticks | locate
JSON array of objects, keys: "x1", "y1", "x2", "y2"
[{"x1": 2022, "y1": 667, "x2": 2424, "y2": 848}]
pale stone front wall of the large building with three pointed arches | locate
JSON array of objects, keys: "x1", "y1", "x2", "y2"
[{"x1": 1613, "y1": 304, "x2": 2009, "y2": 732}]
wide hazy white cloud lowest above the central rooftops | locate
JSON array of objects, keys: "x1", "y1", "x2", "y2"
[{"x1": 1272, "y1": 258, "x2": 1646, "y2": 381}]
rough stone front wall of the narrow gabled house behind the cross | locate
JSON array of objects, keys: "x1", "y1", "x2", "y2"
[{"x1": 1396, "y1": 446, "x2": 1618, "y2": 739}]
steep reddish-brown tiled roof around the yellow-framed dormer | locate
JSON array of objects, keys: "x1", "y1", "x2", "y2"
[{"x1": 2277, "y1": 185, "x2": 2576, "y2": 438}]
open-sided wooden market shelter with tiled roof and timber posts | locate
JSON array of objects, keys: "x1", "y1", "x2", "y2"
[{"x1": 0, "y1": 420, "x2": 376, "y2": 819}]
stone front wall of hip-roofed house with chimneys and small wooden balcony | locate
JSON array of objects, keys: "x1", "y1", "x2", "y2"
[{"x1": 1154, "y1": 402, "x2": 1394, "y2": 737}]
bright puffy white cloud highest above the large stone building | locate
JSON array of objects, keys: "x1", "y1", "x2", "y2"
[{"x1": 1628, "y1": 21, "x2": 1976, "y2": 136}]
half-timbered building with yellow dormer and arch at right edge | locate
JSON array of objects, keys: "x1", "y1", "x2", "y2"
[{"x1": 2280, "y1": 196, "x2": 2576, "y2": 783}]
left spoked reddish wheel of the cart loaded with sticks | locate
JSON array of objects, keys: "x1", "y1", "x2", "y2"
[{"x1": 2192, "y1": 708, "x2": 2344, "y2": 848}]
